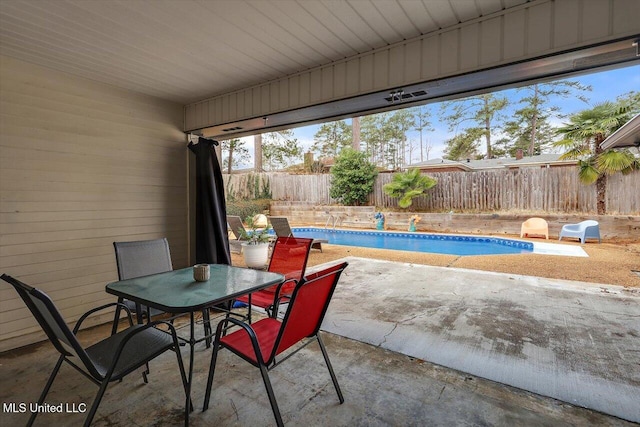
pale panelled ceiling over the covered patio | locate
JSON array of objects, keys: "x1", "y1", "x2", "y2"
[{"x1": 0, "y1": 0, "x2": 528, "y2": 104}]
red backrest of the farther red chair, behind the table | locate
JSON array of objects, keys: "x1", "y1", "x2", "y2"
[{"x1": 268, "y1": 237, "x2": 313, "y2": 293}]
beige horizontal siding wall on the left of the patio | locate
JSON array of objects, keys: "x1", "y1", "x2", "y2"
[{"x1": 0, "y1": 57, "x2": 188, "y2": 351}]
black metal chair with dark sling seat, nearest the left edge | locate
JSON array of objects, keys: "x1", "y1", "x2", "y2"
[{"x1": 0, "y1": 274, "x2": 189, "y2": 426}]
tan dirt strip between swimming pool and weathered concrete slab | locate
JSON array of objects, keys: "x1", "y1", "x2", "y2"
[{"x1": 232, "y1": 235, "x2": 640, "y2": 289}]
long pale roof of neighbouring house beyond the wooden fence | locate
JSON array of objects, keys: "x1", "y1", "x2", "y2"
[{"x1": 409, "y1": 154, "x2": 577, "y2": 171}]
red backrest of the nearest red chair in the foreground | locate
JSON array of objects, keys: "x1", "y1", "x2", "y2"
[{"x1": 269, "y1": 262, "x2": 348, "y2": 361}]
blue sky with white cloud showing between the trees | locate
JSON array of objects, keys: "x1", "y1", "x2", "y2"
[{"x1": 236, "y1": 65, "x2": 640, "y2": 167}]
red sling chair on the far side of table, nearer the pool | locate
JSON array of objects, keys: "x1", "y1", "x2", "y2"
[{"x1": 237, "y1": 237, "x2": 313, "y2": 323}]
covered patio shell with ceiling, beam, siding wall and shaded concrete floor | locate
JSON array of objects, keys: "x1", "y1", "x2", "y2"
[{"x1": 0, "y1": 0, "x2": 640, "y2": 425}]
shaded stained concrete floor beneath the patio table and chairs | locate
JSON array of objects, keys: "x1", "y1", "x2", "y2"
[{"x1": 0, "y1": 262, "x2": 638, "y2": 426}]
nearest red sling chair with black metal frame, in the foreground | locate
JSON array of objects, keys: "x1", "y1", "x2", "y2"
[{"x1": 203, "y1": 262, "x2": 348, "y2": 426}]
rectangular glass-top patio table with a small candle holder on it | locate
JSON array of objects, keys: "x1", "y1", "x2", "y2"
[{"x1": 106, "y1": 264, "x2": 284, "y2": 423}]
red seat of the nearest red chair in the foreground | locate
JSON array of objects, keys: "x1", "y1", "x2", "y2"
[{"x1": 220, "y1": 317, "x2": 280, "y2": 364}]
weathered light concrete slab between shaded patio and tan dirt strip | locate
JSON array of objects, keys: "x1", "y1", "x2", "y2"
[{"x1": 314, "y1": 257, "x2": 640, "y2": 423}]
